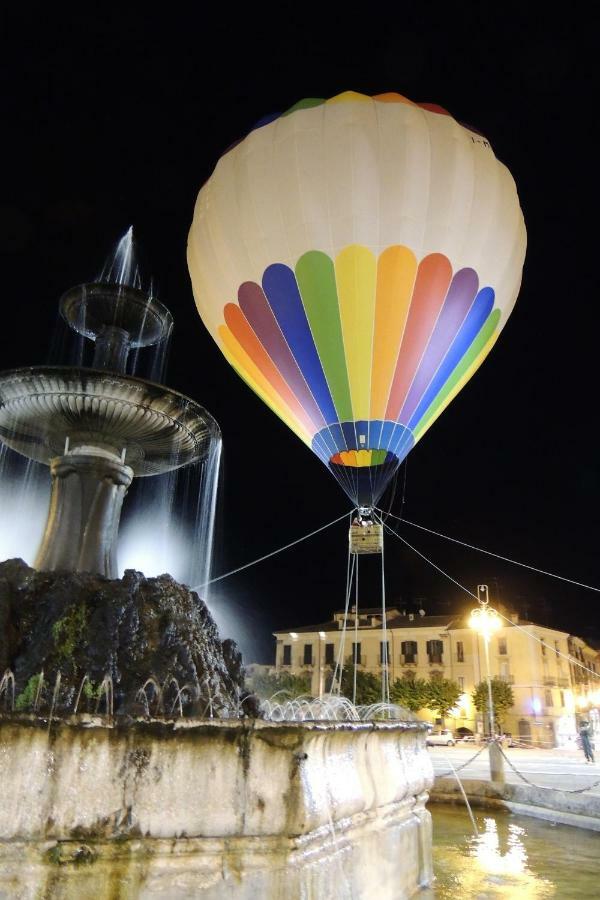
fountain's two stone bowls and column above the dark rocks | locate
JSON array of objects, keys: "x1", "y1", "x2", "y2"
[{"x1": 0, "y1": 243, "x2": 219, "y2": 578}]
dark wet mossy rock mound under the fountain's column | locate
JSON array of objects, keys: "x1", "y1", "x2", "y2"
[{"x1": 0, "y1": 559, "x2": 257, "y2": 716}]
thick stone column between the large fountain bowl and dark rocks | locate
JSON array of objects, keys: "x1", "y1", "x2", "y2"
[{"x1": 35, "y1": 447, "x2": 133, "y2": 578}]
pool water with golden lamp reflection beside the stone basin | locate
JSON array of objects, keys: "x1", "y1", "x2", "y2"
[{"x1": 419, "y1": 804, "x2": 600, "y2": 900}]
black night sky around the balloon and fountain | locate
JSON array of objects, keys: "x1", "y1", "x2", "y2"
[{"x1": 0, "y1": 3, "x2": 600, "y2": 658}]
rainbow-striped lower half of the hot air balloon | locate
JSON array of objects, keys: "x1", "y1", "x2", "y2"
[{"x1": 221, "y1": 246, "x2": 498, "y2": 505}]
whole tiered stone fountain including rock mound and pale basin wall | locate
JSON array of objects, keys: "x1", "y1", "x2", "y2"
[{"x1": 0, "y1": 234, "x2": 433, "y2": 900}]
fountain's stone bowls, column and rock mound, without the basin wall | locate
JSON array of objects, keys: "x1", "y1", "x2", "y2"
[{"x1": 0, "y1": 230, "x2": 244, "y2": 715}]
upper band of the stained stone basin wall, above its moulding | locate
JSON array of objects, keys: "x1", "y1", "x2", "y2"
[{"x1": 0, "y1": 718, "x2": 433, "y2": 841}]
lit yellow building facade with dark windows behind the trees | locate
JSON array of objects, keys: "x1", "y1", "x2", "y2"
[{"x1": 275, "y1": 608, "x2": 600, "y2": 747}]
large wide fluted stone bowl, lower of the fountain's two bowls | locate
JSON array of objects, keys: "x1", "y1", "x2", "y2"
[{"x1": 0, "y1": 366, "x2": 220, "y2": 476}]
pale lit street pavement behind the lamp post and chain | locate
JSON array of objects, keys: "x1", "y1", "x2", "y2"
[{"x1": 428, "y1": 744, "x2": 600, "y2": 795}]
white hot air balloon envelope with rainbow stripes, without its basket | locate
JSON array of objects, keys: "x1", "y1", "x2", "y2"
[{"x1": 188, "y1": 92, "x2": 526, "y2": 509}]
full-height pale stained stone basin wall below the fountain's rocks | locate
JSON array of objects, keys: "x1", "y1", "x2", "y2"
[{"x1": 0, "y1": 717, "x2": 433, "y2": 900}]
